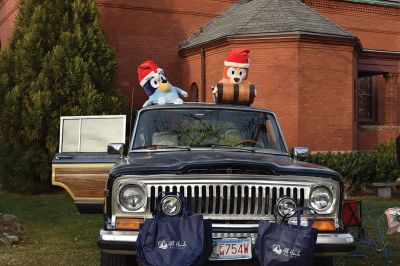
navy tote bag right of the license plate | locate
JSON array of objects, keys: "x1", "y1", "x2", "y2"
[{"x1": 255, "y1": 207, "x2": 318, "y2": 266}]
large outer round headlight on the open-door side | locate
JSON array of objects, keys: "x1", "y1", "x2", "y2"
[{"x1": 120, "y1": 185, "x2": 146, "y2": 211}]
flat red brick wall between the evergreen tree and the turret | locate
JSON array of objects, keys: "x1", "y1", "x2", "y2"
[{"x1": 97, "y1": 0, "x2": 235, "y2": 108}]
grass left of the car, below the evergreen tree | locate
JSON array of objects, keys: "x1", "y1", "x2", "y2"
[{"x1": 0, "y1": 191, "x2": 103, "y2": 266}]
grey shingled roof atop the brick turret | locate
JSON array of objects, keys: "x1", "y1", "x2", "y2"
[{"x1": 179, "y1": 0, "x2": 355, "y2": 50}]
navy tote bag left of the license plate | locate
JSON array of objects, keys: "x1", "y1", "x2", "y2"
[{"x1": 136, "y1": 193, "x2": 212, "y2": 266}]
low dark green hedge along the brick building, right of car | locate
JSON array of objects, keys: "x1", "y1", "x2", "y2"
[{"x1": 307, "y1": 142, "x2": 400, "y2": 189}]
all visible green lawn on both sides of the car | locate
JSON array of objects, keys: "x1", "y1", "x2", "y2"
[{"x1": 0, "y1": 191, "x2": 400, "y2": 266}]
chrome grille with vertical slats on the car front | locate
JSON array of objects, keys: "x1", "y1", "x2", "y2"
[{"x1": 146, "y1": 184, "x2": 309, "y2": 218}]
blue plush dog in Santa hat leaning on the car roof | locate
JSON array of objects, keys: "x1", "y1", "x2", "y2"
[{"x1": 137, "y1": 60, "x2": 188, "y2": 107}]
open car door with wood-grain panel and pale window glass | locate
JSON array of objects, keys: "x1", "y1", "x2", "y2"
[{"x1": 52, "y1": 115, "x2": 126, "y2": 213}]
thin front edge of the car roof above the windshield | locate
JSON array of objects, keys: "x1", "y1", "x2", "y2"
[{"x1": 141, "y1": 102, "x2": 273, "y2": 113}]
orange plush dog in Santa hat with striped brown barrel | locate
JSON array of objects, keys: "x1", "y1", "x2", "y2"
[{"x1": 212, "y1": 48, "x2": 256, "y2": 105}]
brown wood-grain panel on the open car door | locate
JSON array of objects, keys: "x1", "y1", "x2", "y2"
[{"x1": 52, "y1": 164, "x2": 113, "y2": 201}]
